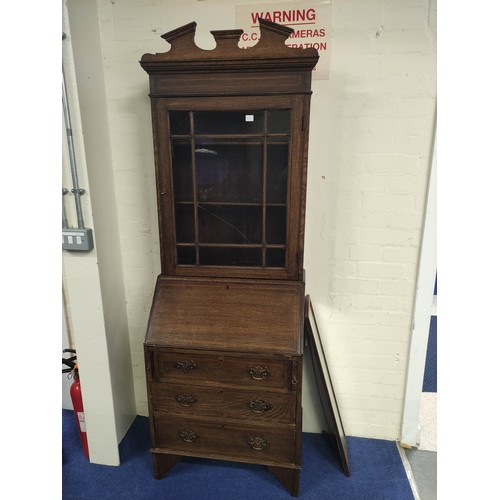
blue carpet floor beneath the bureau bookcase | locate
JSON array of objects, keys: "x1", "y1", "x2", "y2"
[{"x1": 62, "y1": 410, "x2": 413, "y2": 500}]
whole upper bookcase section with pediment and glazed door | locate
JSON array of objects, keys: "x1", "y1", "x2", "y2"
[{"x1": 140, "y1": 19, "x2": 318, "y2": 280}]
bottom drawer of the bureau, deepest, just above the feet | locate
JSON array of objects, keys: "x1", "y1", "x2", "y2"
[{"x1": 154, "y1": 412, "x2": 297, "y2": 465}]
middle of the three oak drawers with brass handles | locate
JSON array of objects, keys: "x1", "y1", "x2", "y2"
[{"x1": 150, "y1": 382, "x2": 297, "y2": 425}]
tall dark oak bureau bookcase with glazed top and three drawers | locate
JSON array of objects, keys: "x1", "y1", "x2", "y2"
[{"x1": 140, "y1": 20, "x2": 318, "y2": 496}]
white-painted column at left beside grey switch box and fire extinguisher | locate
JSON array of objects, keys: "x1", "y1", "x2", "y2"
[{"x1": 63, "y1": 0, "x2": 136, "y2": 465}]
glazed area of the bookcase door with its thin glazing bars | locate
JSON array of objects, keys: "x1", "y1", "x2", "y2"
[{"x1": 169, "y1": 109, "x2": 291, "y2": 268}]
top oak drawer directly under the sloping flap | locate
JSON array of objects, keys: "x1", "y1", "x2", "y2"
[{"x1": 152, "y1": 350, "x2": 299, "y2": 390}]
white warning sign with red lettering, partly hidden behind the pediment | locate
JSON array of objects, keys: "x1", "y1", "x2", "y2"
[{"x1": 236, "y1": 2, "x2": 331, "y2": 80}]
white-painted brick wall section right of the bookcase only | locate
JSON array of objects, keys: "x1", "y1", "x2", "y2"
[{"x1": 305, "y1": 0, "x2": 436, "y2": 439}]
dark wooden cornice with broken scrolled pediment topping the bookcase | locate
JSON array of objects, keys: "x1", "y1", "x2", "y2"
[{"x1": 140, "y1": 19, "x2": 319, "y2": 74}]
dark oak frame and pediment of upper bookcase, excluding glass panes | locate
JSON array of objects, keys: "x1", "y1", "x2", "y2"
[{"x1": 140, "y1": 20, "x2": 318, "y2": 280}]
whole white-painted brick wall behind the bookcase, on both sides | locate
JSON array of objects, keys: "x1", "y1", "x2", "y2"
[{"x1": 88, "y1": 0, "x2": 436, "y2": 439}]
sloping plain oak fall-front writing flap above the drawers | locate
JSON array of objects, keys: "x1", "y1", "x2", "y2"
[{"x1": 146, "y1": 276, "x2": 304, "y2": 355}]
